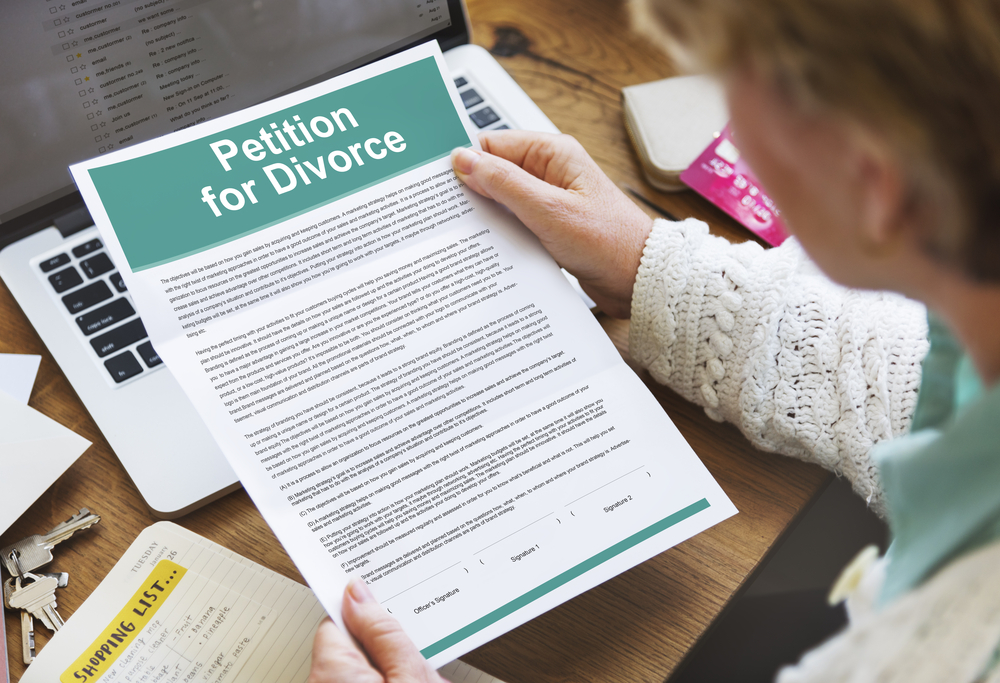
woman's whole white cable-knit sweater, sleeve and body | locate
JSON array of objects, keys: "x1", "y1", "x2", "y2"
[{"x1": 629, "y1": 220, "x2": 1000, "y2": 683}]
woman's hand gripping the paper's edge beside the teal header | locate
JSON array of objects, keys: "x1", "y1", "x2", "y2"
[{"x1": 452, "y1": 131, "x2": 653, "y2": 318}]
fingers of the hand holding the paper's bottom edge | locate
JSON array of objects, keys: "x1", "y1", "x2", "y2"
[{"x1": 309, "y1": 579, "x2": 446, "y2": 683}]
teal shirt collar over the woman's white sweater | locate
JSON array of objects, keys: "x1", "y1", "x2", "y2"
[{"x1": 872, "y1": 317, "x2": 1000, "y2": 604}]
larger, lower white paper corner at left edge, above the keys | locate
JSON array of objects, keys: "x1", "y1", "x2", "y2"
[{"x1": 0, "y1": 392, "x2": 90, "y2": 533}]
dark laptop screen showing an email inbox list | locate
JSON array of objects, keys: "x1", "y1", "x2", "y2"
[{"x1": 0, "y1": 0, "x2": 467, "y2": 221}]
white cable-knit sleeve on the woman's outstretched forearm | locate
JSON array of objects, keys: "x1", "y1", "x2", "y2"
[{"x1": 629, "y1": 219, "x2": 928, "y2": 515}]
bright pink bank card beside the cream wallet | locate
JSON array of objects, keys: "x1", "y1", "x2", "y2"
[{"x1": 681, "y1": 124, "x2": 788, "y2": 246}]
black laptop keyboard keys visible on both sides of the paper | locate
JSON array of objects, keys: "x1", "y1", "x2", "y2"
[{"x1": 37, "y1": 76, "x2": 510, "y2": 385}]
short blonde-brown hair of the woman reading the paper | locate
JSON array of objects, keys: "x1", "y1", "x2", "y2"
[{"x1": 632, "y1": 0, "x2": 1000, "y2": 281}]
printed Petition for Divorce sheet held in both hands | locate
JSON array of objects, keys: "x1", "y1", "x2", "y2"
[{"x1": 72, "y1": 44, "x2": 735, "y2": 665}]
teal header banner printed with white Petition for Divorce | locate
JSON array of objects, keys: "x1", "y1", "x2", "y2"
[{"x1": 89, "y1": 57, "x2": 471, "y2": 272}]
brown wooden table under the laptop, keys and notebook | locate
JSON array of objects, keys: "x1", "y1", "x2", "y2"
[{"x1": 0, "y1": 0, "x2": 828, "y2": 683}]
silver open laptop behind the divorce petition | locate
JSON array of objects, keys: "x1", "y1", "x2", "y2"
[{"x1": 0, "y1": 0, "x2": 558, "y2": 519}]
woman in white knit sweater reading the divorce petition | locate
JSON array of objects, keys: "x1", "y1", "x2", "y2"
[{"x1": 312, "y1": 0, "x2": 1000, "y2": 683}]
